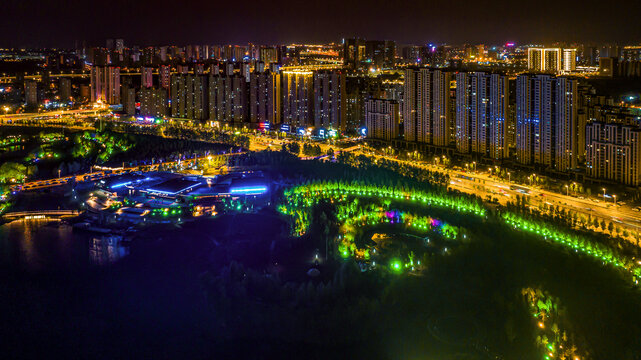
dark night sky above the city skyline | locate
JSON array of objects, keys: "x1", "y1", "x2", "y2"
[{"x1": 0, "y1": 0, "x2": 641, "y2": 48}]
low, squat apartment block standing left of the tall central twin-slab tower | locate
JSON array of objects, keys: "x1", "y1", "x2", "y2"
[{"x1": 365, "y1": 99, "x2": 400, "y2": 141}]
